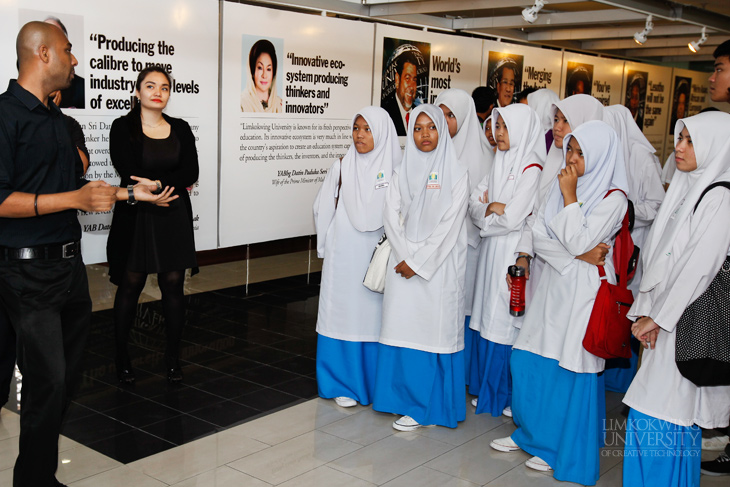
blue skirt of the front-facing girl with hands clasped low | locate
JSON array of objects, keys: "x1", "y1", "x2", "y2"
[{"x1": 373, "y1": 343, "x2": 466, "y2": 428}]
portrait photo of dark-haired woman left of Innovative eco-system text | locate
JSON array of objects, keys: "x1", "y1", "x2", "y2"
[{"x1": 241, "y1": 34, "x2": 284, "y2": 113}]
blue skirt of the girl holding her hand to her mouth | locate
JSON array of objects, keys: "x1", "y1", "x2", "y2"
[{"x1": 510, "y1": 350, "x2": 605, "y2": 485}]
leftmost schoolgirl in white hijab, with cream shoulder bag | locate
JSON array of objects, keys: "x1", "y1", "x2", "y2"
[{"x1": 314, "y1": 107, "x2": 401, "y2": 407}]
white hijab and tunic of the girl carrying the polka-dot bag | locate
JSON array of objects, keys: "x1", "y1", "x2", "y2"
[{"x1": 624, "y1": 112, "x2": 730, "y2": 428}]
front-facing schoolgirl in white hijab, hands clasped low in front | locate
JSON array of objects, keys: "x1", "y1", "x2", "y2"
[{"x1": 373, "y1": 104, "x2": 469, "y2": 431}]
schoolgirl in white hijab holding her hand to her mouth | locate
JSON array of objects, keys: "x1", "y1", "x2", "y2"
[{"x1": 491, "y1": 121, "x2": 628, "y2": 485}]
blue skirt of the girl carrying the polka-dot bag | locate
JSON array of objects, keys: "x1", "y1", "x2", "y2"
[{"x1": 624, "y1": 409, "x2": 702, "y2": 487}]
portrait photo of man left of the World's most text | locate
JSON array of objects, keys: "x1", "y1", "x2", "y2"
[{"x1": 380, "y1": 37, "x2": 431, "y2": 136}]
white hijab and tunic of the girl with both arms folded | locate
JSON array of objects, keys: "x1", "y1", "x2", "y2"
[{"x1": 469, "y1": 104, "x2": 546, "y2": 345}]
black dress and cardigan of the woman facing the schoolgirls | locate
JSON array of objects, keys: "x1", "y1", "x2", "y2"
[{"x1": 107, "y1": 114, "x2": 198, "y2": 284}]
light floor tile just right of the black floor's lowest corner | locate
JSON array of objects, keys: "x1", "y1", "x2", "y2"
[{"x1": 128, "y1": 435, "x2": 218, "y2": 484}]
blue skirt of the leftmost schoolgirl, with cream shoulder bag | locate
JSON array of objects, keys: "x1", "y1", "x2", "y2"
[{"x1": 317, "y1": 335, "x2": 378, "y2": 406}]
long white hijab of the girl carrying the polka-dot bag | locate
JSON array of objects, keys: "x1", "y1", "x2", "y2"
[{"x1": 639, "y1": 112, "x2": 730, "y2": 292}]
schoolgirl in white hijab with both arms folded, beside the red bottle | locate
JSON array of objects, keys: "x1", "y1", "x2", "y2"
[{"x1": 469, "y1": 103, "x2": 546, "y2": 416}]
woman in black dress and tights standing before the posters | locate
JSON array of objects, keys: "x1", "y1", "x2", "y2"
[{"x1": 107, "y1": 67, "x2": 198, "y2": 384}]
